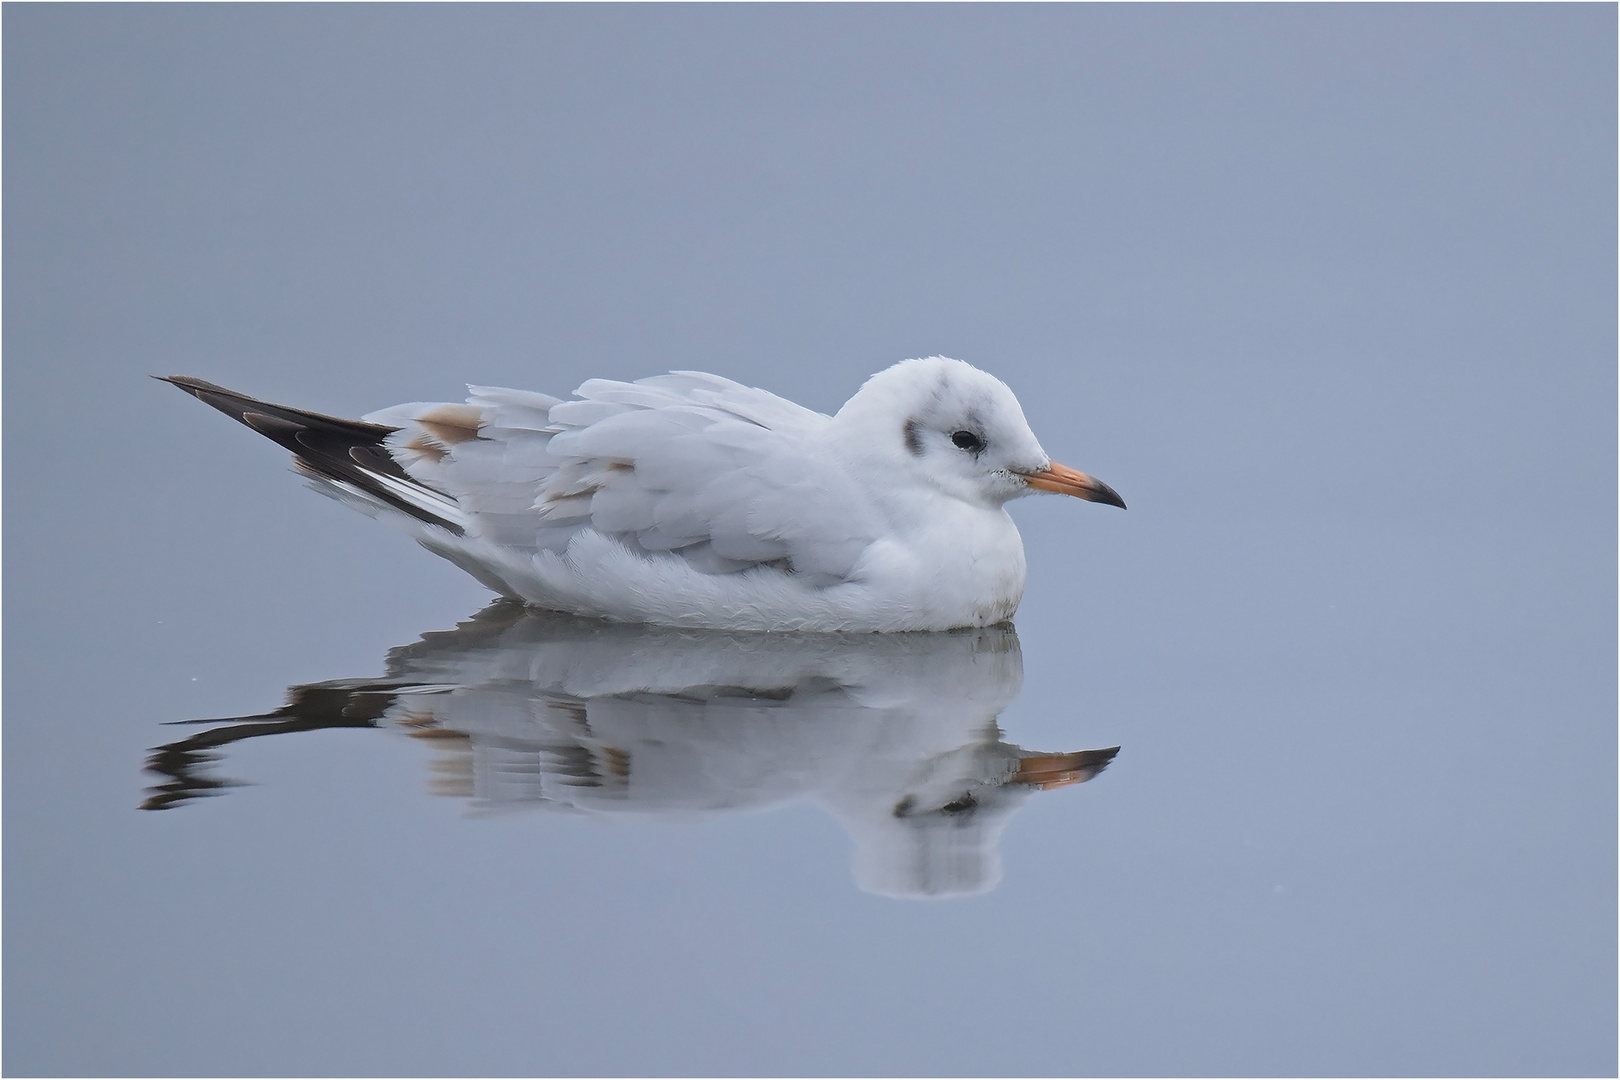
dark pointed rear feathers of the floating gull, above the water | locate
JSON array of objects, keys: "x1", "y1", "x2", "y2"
[{"x1": 154, "y1": 376, "x2": 465, "y2": 536}]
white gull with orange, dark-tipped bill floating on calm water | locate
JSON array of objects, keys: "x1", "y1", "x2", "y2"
[{"x1": 164, "y1": 356, "x2": 1124, "y2": 631}]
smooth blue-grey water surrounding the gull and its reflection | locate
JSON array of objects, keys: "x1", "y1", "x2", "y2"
[{"x1": 3, "y1": 5, "x2": 1617, "y2": 1075}]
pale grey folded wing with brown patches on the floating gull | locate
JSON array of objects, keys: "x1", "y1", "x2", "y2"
[{"x1": 366, "y1": 372, "x2": 878, "y2": 585}]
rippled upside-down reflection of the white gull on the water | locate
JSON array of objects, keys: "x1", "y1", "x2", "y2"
[{"x1": 146, "y1": 601, "x2": 1118, "y2": 895}]
